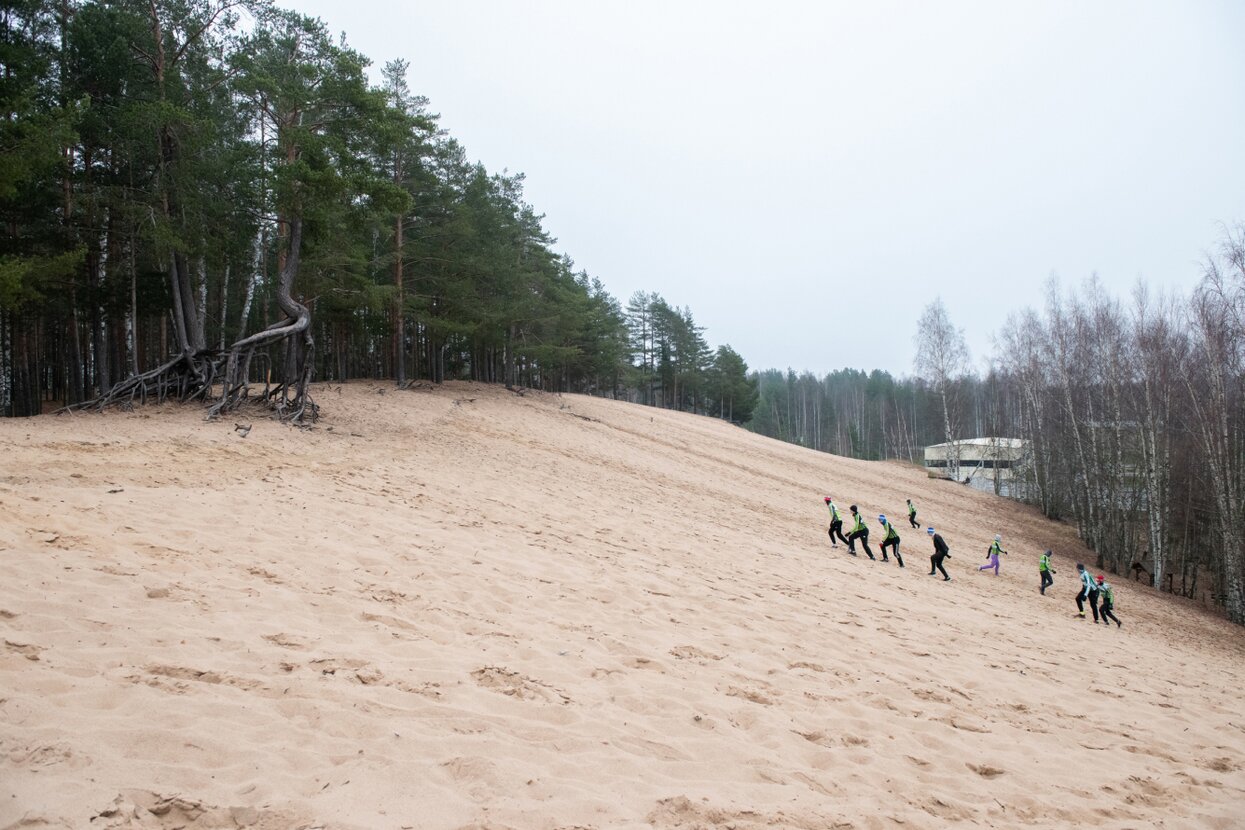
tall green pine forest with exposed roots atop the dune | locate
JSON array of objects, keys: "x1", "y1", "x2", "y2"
[{"x1": 0, "y1": 0, "x2": 754, "y2": 422}]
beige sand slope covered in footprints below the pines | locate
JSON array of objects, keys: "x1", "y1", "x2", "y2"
[{"x1": 0, "y1": 383, "x2": 1245, "y2": 830}]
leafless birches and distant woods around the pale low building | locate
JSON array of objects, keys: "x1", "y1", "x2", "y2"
[{"x1": 749, "y1": 229, "x2": 1245, "y2": 623}]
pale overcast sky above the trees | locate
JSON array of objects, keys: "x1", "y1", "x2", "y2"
[{"x1": 286, "y1": 0, "x2": 1245, "y2": 375}]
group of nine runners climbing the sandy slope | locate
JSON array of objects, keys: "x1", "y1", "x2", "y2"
[{"x1": 825, "y1": 495, "x2": 1123, "y2": 627}]
